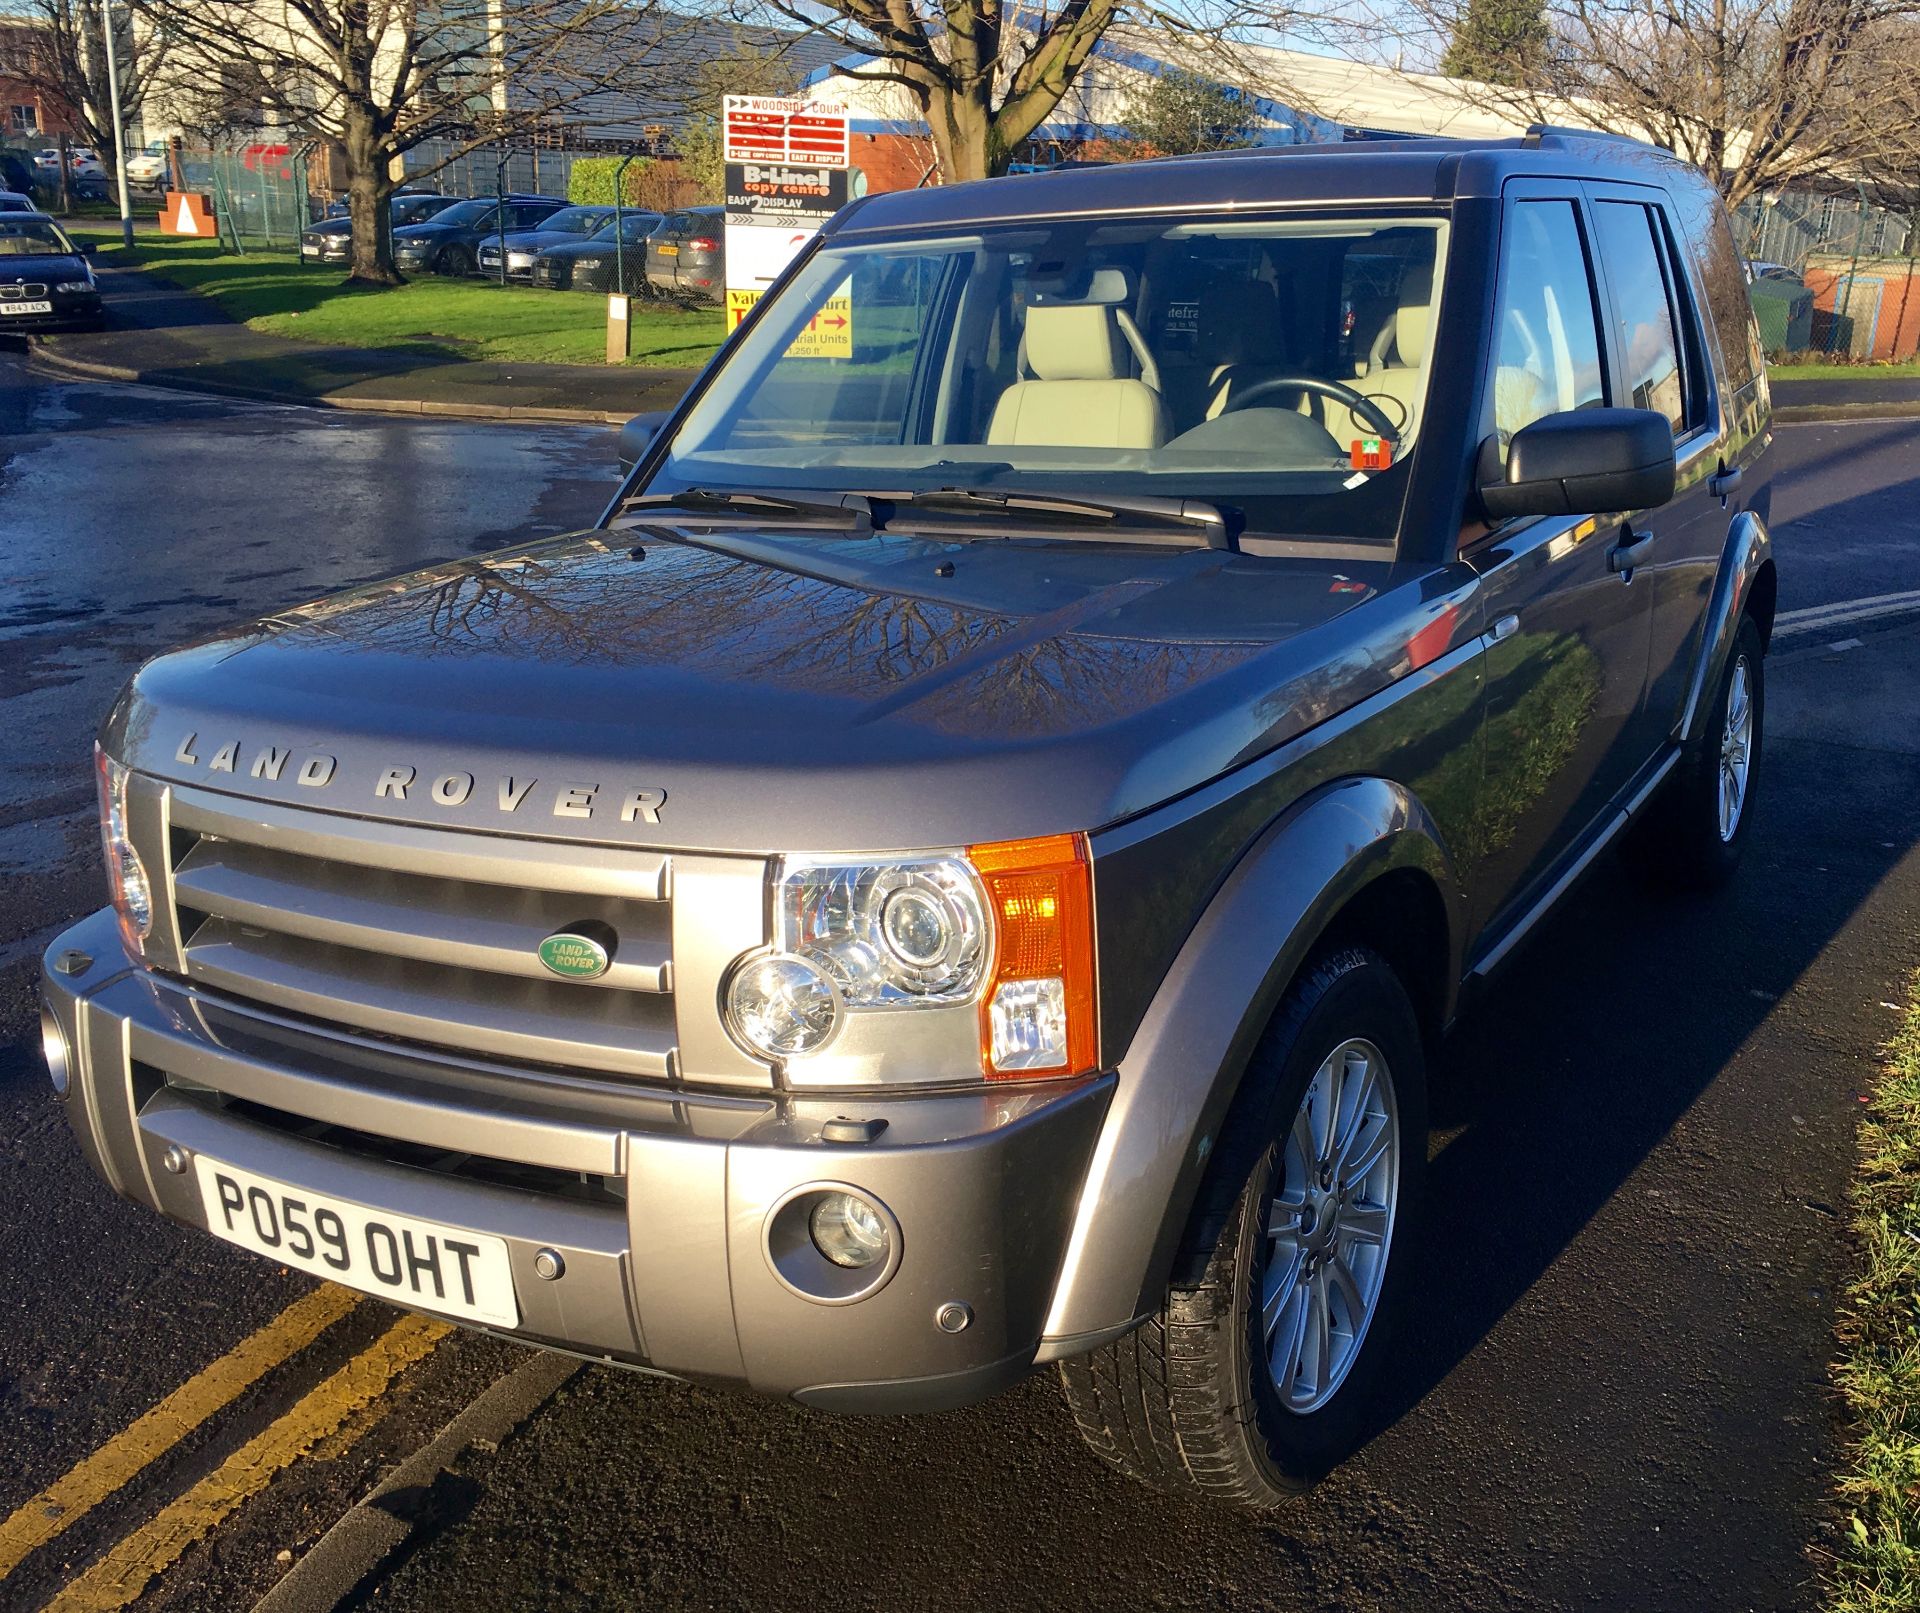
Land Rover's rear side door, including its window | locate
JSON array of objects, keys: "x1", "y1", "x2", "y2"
[{"x1": 1588, "y1": 184, "x2": 1730, "y2": 745}]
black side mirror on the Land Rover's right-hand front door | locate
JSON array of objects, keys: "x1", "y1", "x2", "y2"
[{"x1": 1475, "y1": 409, "x2": 1674, "y2": 520}]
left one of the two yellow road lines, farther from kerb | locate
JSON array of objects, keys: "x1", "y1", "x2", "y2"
[{"x1": 0, "y1": 1283, "x2": 359, "y2": 1580}]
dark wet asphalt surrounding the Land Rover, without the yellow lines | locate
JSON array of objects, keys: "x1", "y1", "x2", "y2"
[{"x1": 0, "y1": 355, "x2": 1920, "y2": 1609}]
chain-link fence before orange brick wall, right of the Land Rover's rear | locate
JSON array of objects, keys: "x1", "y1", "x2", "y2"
[{"x1": 1736, "y1": 192, "x2": 1920, "y2": 361}]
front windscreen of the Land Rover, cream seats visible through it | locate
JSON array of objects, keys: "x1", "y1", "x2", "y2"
[{"x1": 664, "y1": 213, "x2": 1446, "y2": 542}]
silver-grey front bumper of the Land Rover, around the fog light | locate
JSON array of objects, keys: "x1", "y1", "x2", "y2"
[{"x1": 42, "y1": 912, "x2": 1112, "y2": 1411}]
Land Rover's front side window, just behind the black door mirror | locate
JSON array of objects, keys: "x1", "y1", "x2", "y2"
[{"x1": 1482, "y1": 202, "x2": 1607, "y2": 457}]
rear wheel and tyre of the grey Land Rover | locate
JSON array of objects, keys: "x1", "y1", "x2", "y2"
[{"x1": 1630, "y1": 616, "x2": 1766, "y2": 891}]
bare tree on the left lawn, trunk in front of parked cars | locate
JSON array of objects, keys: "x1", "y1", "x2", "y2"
[{"x1": 142, "y1": 0, "x2": 699, "y2": 286}]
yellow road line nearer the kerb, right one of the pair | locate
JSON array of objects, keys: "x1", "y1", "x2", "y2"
[{"x1": 46, "y1": 1315, "x2": 453, "y2": 1613}]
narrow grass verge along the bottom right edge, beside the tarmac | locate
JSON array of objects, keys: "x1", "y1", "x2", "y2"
[{"x1": 1824, "y1": 975, "x2": 1920, "y2": 1613}]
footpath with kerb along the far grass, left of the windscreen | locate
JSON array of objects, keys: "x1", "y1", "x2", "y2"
[{"x1": 33, "y1": 263, "x2": 699, "y2": 424}]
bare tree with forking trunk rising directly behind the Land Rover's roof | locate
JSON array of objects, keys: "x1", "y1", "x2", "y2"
[{"x1": 744, "y1": 0, "x2": 1286, "y2": 182}]
